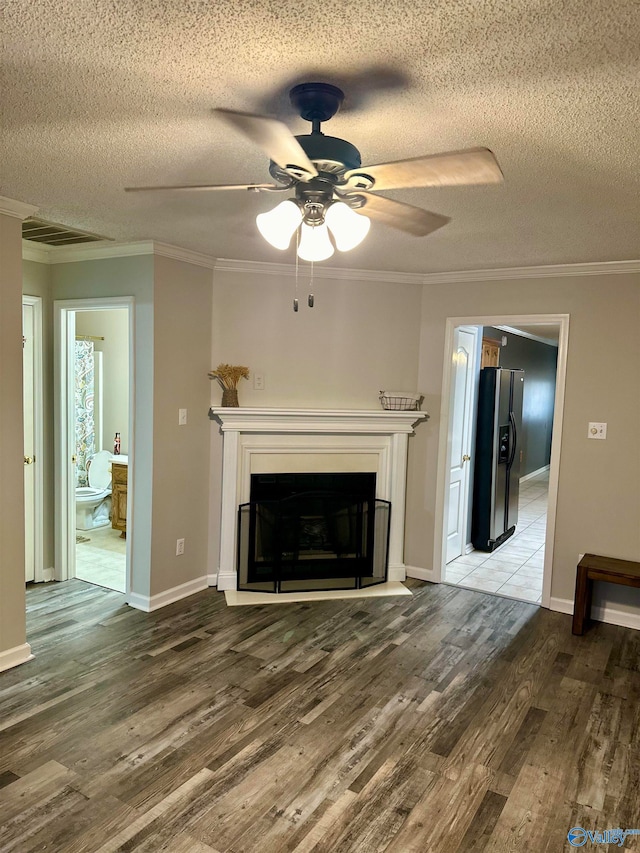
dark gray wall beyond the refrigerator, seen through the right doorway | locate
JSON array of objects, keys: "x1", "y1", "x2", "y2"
[{"x1": 482, "y1": 326, "x2": 558, "y2": 477}]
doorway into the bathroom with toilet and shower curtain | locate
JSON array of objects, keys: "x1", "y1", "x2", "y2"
[{"x1": 54, "y1": 297, "x2": 134, "y2": 593}]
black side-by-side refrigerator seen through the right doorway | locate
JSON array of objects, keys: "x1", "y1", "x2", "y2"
[{"x1": 471, "y1": 367, "x2": 524, "y2": 551}]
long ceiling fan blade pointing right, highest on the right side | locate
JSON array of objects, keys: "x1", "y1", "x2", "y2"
[{"x1": 345, "y1": 148, "x2": 504, "y2": 191}]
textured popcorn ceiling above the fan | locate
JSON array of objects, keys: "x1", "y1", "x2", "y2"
[{"x1": 0, "y1": 0, "x2": 640, "y2": 272}]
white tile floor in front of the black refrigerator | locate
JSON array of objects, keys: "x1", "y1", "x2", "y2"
[{"x1": 444, "y1": 471, "x2": 549, "y2": 604}]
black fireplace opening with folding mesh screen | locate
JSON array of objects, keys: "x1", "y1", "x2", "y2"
[{"x1": 237, "y1": 472, "x2": 391, "y2": 593}]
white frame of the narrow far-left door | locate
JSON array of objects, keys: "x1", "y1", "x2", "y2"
[{"x1": 22, "y1": 293, "x2": 45, "y2": 583}]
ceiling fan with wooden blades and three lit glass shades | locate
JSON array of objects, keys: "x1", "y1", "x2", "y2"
[{"x1": 126, "y1": 83, "x2": 503, "y2": 261}]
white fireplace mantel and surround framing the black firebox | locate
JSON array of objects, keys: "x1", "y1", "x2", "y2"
[{"x1": 210, "y1": 408, "x2": 428, "y2": 590}]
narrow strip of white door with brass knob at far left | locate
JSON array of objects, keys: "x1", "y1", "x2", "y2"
[{"x1": 22, "y1": 304, "x2": 36, "y2": 582}]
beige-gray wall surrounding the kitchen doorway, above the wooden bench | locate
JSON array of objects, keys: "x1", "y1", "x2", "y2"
[{"x1": 405, "y1": 273, "x2": 640, "y2": 612}]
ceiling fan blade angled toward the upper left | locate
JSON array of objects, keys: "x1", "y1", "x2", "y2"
[{"x1": 214, "y1": 109, "x2": 318, "y2": 180}]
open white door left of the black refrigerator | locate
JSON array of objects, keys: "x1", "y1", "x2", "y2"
[{"x1": 445, "y1": 326, "x2": 479, "y2": 563}]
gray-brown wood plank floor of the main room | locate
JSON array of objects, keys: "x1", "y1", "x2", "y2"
[{"x1": 0, "y1": 581, "x2": 640, "y2": 853}]
